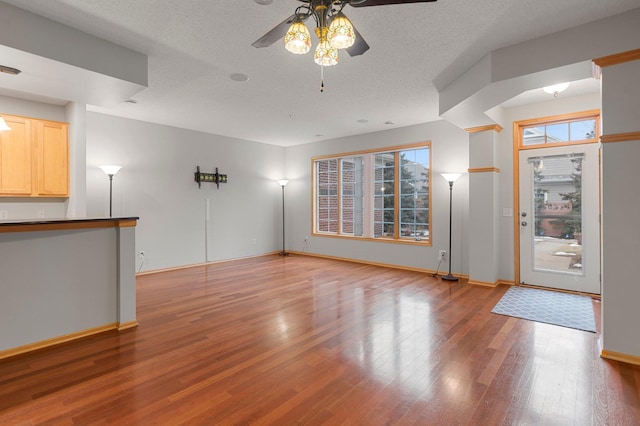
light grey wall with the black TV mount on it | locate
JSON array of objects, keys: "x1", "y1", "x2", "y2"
[{"x1": 86, "y1": 113, "x2": 284, "y2": 271}]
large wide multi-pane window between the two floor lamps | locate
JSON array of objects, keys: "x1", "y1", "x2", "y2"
[{"x1": 313, "y1": 142, "x2": 431, "y2": 244}]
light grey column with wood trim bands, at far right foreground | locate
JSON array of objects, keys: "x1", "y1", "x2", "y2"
[{"x1": 595, "y1": 56, "x2": 640, "y2": 364}]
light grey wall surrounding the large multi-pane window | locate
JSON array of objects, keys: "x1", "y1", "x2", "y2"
[{"x1": 286, "y1": 121, "x2": 469, "y2": 274}]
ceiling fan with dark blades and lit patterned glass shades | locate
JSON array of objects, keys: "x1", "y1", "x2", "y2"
[{"x1": 251, "y1": 0, "x2": 437, "y2": 67}]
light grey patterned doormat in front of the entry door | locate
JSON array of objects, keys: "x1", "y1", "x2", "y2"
[{"x1": 491, "y1": 287, "x2": 596, "y2": 333}]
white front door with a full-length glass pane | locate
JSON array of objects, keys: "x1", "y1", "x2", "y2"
[{"x1": 518, "y1": 143, "x2": 600, "y2": 294}]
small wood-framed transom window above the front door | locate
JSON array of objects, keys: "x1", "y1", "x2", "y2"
[{"x1": 521, "y1": 111, "x2": 600, "y2": 147}]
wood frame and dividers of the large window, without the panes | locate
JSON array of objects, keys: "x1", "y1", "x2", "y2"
[{"x1": 311, "y1": 141, "x2": 433, "y2": 246}]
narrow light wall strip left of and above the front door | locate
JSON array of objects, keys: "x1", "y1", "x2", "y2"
[{"x1": 498, "y1": 93, "x2": 600, "y2": 281}]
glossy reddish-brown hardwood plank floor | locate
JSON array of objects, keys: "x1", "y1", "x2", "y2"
[{"x1": 0, "y1": 256, "x2": 640, "y2": 425}]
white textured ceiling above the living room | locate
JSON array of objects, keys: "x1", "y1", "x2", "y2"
[{"x1": 5, "y1": 0, "x2": 640, "y2": 146}]
